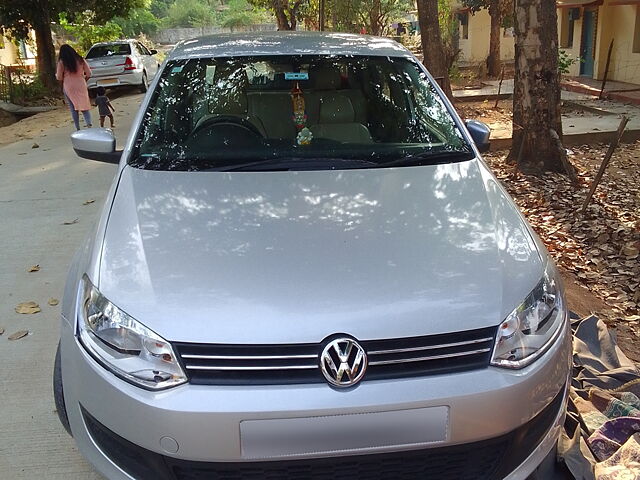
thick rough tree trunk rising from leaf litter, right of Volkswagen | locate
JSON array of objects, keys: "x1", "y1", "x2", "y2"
[{"x1": 509, "y1": 0, "x2": 568, "y2": 174}]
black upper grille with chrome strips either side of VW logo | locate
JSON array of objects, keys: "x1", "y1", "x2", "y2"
[{"x1": 174, "y1": 327, "x2": 496, "y2": 385}]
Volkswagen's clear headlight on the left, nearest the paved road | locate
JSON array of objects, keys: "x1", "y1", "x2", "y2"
[{"x1": 78, "y1": 275, "x2": 187, "y2": 390}]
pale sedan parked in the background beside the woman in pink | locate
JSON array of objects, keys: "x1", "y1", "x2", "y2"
[{"x1": 85, "y1": 40, "x2": 160, "y2": 92}]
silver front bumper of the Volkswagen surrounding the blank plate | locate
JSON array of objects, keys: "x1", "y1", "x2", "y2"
[{"x1": 61, "y1": 321, "x2": 571, "y2": 480}]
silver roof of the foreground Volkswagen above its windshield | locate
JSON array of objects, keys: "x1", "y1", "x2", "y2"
[{"x1": 169, "y1": 31, "x2": 412, "y2": 60}]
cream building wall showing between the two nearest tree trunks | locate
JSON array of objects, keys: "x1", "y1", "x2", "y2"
[{"x1": 459, "y1": 9, "x2": 515, "y2": 62}]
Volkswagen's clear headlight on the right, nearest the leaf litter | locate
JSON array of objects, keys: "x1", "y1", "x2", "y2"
[{"x1": 491, "y1": 261, "x2": 568, "y2": 368}]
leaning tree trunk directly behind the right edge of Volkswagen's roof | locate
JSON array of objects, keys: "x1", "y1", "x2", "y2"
[{"x1": 418, "y1": 0, "x2": 452, "y2": 98}]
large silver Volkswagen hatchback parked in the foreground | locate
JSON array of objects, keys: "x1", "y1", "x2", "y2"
[{"x1": 54, "y1": 32, "x2": 571, "y2": 480}]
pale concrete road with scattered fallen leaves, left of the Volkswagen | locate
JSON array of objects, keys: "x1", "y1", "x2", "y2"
[{"x1": 0, "y1": 94, "x2": 142, "y2": 480}]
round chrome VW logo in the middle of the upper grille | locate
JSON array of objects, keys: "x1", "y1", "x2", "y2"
[{"x1": 320, "y1": 337, "x2": 367, "y2": 387}]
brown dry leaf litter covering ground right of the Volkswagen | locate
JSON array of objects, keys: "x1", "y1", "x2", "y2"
[{"x1": 485, "y1": 142, "x2": 640, "y2": 330}]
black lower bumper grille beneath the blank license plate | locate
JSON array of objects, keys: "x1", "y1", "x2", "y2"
[{"x1": 81, "y1": 389, "x2": 564, "y2": 480}]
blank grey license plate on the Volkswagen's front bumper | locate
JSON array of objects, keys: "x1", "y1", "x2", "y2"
[{"x1": 240, "y1": 406, "x2": 449, "y2": 459}]
